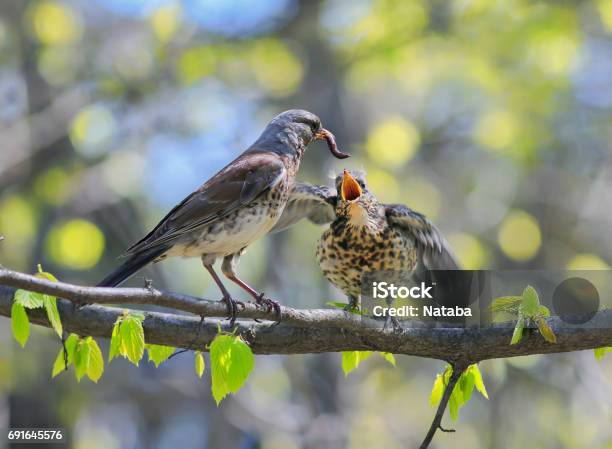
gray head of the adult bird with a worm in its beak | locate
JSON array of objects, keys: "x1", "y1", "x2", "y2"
[{"x1": 251, "y1": 109, "x2": 349, "y2": 159}]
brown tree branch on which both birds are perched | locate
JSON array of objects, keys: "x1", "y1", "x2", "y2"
[{"x1": 0, "y1": 268, "x2": 612, "y2": 364}]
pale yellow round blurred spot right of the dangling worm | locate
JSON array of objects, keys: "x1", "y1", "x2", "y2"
[{"x1": 366, "y1": 117, "x2": 421, "y2": 167}]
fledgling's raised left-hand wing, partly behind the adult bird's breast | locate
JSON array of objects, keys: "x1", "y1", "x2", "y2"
[{"x1": 270, "y1": 182, "x2": 337, "y2": 232}]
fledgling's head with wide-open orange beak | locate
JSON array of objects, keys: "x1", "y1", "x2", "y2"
[{"x1": 336, "y1": 170, "x2": 385, "y2": 228}]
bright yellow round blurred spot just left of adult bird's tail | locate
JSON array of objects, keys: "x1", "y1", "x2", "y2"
[{"x1": 46, "y1": 219, "x2": 105, "y2": 270}]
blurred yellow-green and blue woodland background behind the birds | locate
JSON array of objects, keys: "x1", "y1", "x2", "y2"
[{"x1": 0, "y1": 0, "x2": 612, "y2": 449}]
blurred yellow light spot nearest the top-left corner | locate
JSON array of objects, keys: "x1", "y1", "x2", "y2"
[{"x1": 28, "y1": 1, "x2": 83, "y2": 45}]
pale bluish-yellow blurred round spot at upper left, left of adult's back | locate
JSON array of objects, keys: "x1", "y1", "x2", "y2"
[{"x1": 70, "y1": 104, "x2": 116, "y2": 156}]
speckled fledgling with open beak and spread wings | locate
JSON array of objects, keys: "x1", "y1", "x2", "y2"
[{"x1": 273, "y1": 170, "x2": 459, "y2": 309}]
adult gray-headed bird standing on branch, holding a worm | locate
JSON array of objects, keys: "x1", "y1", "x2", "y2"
[{"x1": 98, "y1": 109, "x2": 348, "y2": 322}]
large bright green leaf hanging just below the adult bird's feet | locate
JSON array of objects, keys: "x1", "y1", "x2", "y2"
[{"x1": 210, "y1": 334, "x2": 255, "y2": 405}]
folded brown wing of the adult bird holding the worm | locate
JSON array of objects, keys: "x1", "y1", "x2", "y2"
[{"x1": 125, "y1": 153, "x2": 286, "y2": 256}]
